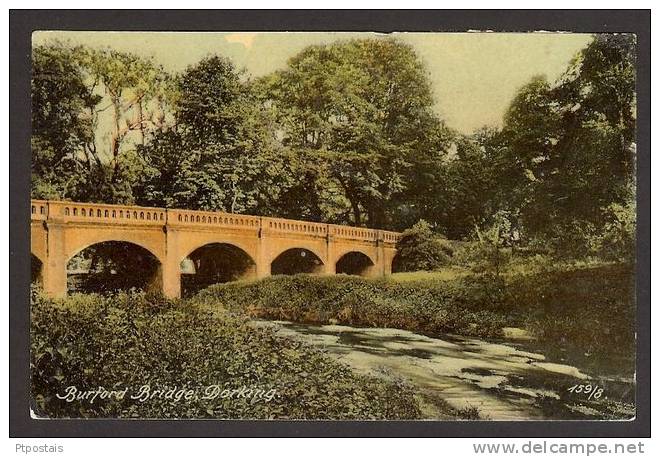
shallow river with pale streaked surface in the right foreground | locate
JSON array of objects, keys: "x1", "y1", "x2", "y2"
[{"x1": 254, "y1": 321, "x2": 634, "y2": 420}]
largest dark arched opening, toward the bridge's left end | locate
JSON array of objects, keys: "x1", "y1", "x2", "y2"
[{"x1": 66, "y1": 241, "x2": 161, "y2": 294}]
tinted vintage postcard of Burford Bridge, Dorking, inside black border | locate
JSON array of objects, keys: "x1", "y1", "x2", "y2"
[{"x1": 29, "y1": 30, "x2": 637, "y2": 421}]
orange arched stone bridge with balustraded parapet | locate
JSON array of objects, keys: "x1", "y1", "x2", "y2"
[{"x1": 31, "y1": 200, "x2": 399, "y2": 298}]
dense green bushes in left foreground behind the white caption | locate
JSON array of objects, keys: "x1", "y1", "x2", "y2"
[{"x1": 31, "y1": 294, "x2": 419, "y2": 419}]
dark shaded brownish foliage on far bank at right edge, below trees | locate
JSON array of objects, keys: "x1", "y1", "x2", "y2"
[{"x1": 510, "y1": 264, "x2": 636, "y2": 357}]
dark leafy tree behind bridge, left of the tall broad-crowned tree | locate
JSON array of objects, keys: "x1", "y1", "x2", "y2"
[{"x1": 138, "y1": 56, "x2": 286, "y2": 213}]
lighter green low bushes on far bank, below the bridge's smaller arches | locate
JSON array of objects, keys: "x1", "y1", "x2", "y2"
[{"x1": 197, "y1": 275, "x2": 508, "y2": 336}]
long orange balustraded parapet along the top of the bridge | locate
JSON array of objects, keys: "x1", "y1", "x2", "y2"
[{"x1": 31, "y1": 200, "x2": 401, "y2": 243}]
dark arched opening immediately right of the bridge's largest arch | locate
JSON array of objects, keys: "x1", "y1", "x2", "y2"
[{"x1": 181, "y1": 243, "x2": 257, "y2": 297}]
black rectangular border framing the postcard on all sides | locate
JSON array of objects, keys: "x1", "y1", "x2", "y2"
[{"x1": 9, "y1": 10, "x2": 651, "y2": 438}]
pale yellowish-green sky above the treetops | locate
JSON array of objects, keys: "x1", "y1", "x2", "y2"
[{"x1": 32, "y1": 31, "x2": 591, "y2": 133}]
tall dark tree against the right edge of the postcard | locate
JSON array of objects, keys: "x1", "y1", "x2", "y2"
[{"x1": 490, "y1": 34, "x2": 635, "y2": 252}]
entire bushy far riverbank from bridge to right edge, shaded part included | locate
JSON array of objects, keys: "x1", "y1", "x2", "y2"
[{"x1": 204, "y1": 265, "x2": 635, "y2": 354}]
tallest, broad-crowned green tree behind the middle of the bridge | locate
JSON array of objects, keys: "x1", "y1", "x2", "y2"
[{"x1": 259, "y1": 39, "x2": 454, "y2": 227}]
